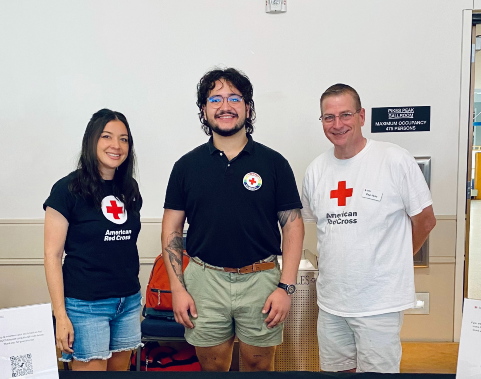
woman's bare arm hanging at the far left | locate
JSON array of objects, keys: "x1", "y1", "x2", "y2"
[{"x1": 44, "y1": 207, "x2": 74, "y2": 353}]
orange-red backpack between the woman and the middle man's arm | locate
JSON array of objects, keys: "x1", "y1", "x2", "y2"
[{"x1": 145, "y1": 251, "x2": 189, "y2": 315}]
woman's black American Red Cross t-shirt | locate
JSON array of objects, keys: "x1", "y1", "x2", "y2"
[{"x1": 43, "y1": 172, "x2": 142, "y2": 300}]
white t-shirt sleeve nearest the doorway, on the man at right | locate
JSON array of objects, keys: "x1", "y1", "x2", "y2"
[{"x1": 401, "y1": 157, "x2": 433, "y2": 217}]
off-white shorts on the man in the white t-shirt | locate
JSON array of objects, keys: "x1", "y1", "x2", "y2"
[{"x1": 317, "y1": 309, "x2": 404, "y2": 374}]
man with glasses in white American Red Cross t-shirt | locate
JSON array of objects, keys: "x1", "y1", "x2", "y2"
[{"x1": 302, "y1": 84, "x2": 436, "y2": 373}]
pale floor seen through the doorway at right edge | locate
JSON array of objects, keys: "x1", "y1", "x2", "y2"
[{"x1": 468, "y1": 200, "x2": 481, "y2": 299}]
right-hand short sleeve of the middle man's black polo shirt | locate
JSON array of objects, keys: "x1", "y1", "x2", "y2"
[{"x1": 276, "y1": 158, "x2": 302, "y2": 212}]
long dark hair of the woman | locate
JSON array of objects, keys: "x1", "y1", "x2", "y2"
[{"x1": 69, "y1": 109, "x2": 140, "y2": 211}]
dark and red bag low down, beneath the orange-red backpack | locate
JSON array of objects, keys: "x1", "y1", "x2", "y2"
[{"x1": 130, "y1": 342, "x2": 201, "y2": 371}]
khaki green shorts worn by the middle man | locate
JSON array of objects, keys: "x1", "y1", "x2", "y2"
[{"x1": 184, "y1": 258, "x2": 283, "y2": 347}]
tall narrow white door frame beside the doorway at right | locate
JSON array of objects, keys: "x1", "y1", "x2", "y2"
[{"x1": 453, "y1": 10, "x2": 473, "y2": 342}]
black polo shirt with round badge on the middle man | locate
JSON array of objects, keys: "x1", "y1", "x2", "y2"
[{"x1": 164, "y1": 135, "x2": 302, "y2": 268}]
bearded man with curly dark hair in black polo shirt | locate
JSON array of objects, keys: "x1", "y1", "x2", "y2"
[{"x1": 162, "y1": 68, "x2": 304, "y2": 371}]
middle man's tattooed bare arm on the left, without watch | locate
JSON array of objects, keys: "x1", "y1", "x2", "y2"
[{"x1": 158, "y1": 209, "x2": 197, "y2": 328}]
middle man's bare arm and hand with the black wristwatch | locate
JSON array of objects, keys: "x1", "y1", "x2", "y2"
[{"x1": 262, "y1": 209, "x2": 304, "y2": 328}]
